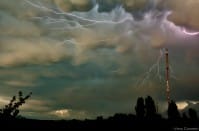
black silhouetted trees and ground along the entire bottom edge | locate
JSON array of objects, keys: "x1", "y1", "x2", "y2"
[{"x1": 0, "y1": 92, "x2": 199, "y2": 130}]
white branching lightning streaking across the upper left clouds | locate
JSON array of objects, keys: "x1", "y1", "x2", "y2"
[{"x1": 25, "y1": 0, "x2": 133, "y2": 43}]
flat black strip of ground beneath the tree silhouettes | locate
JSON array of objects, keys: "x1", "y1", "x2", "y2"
[{"x1": 0, "y1": 114, "x2": 199, "y2": 131}]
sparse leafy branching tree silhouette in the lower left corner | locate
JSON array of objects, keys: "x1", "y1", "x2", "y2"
[{"x1": 0, "y1": 91, "x2": 32, "y2": 119}]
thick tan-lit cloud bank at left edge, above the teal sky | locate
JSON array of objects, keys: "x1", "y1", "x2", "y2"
[{"x1": 0, "y1": 37, "x2": 70, "y2": 67}]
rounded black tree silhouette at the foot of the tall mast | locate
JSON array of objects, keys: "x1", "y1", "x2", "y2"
[{"x1": 167, "y1": 100, "x2": 180, "y2": 120}]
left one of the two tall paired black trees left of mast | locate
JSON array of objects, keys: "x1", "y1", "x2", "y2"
[{"x1": 135, "y1": 97, "x2": 145, "y2": 118}]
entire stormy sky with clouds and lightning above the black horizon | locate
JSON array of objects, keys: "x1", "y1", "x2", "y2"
[{"x1": 0, "y1": 0, "x2": 199, "y2": 119}]
